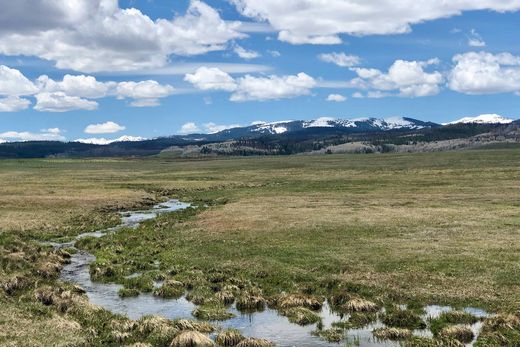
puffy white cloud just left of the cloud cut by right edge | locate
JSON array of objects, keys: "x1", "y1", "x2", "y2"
[{"x1": 351, "y1": 59, "x2": 444, "y2": 98}]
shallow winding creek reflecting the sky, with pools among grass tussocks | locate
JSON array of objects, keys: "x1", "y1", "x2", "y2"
[{"x1": 53, "y1": 200, "x2": 487, "y2": 347}]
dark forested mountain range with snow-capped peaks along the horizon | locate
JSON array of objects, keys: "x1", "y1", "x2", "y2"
[{"x1": 0, "y1": 114, "x2": 520, "y2": 158}]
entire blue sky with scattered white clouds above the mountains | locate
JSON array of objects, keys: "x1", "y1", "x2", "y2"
[{"x1": 0, "y1": 0, "x2": 520, "y2": 143}]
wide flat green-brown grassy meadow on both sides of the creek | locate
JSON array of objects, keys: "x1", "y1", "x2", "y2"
[{"x1": 0, "y1": 148, "x2": 520, "y2": 346}]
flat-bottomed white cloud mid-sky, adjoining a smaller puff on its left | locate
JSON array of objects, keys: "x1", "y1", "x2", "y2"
[{"x1": 230, "y1": 72, "x2": 316, "y2": 101}]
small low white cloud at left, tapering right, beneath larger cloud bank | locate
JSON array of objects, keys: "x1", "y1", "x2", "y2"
[{"x1": 34, "y1": 92, "x2": 98, "y2": 112}]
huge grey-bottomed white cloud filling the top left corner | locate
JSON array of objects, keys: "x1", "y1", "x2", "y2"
[{"x1": 0, "y1": 0, "x2": 244, "y2": 72}]
